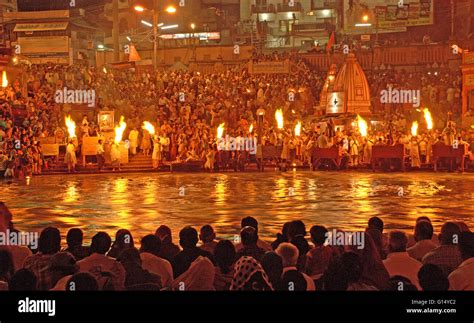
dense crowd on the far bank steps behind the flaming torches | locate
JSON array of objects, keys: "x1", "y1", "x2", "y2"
[{"x1": 0, "y1": 54, "x2": 474, "y2": 178}]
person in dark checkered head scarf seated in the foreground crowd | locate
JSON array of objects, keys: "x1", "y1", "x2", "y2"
[{"x1": 230, "y1": 256, "x2": 273, "y2": 291}]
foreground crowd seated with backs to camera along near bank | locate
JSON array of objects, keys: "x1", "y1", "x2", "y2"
[{"x1": 0, "y1": 204, "x2": 474, "y2": 291}]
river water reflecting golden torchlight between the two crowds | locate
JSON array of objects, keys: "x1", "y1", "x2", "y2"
[{"x1": 0, "y1": 171, "x2": 474, "y2": 241}]
